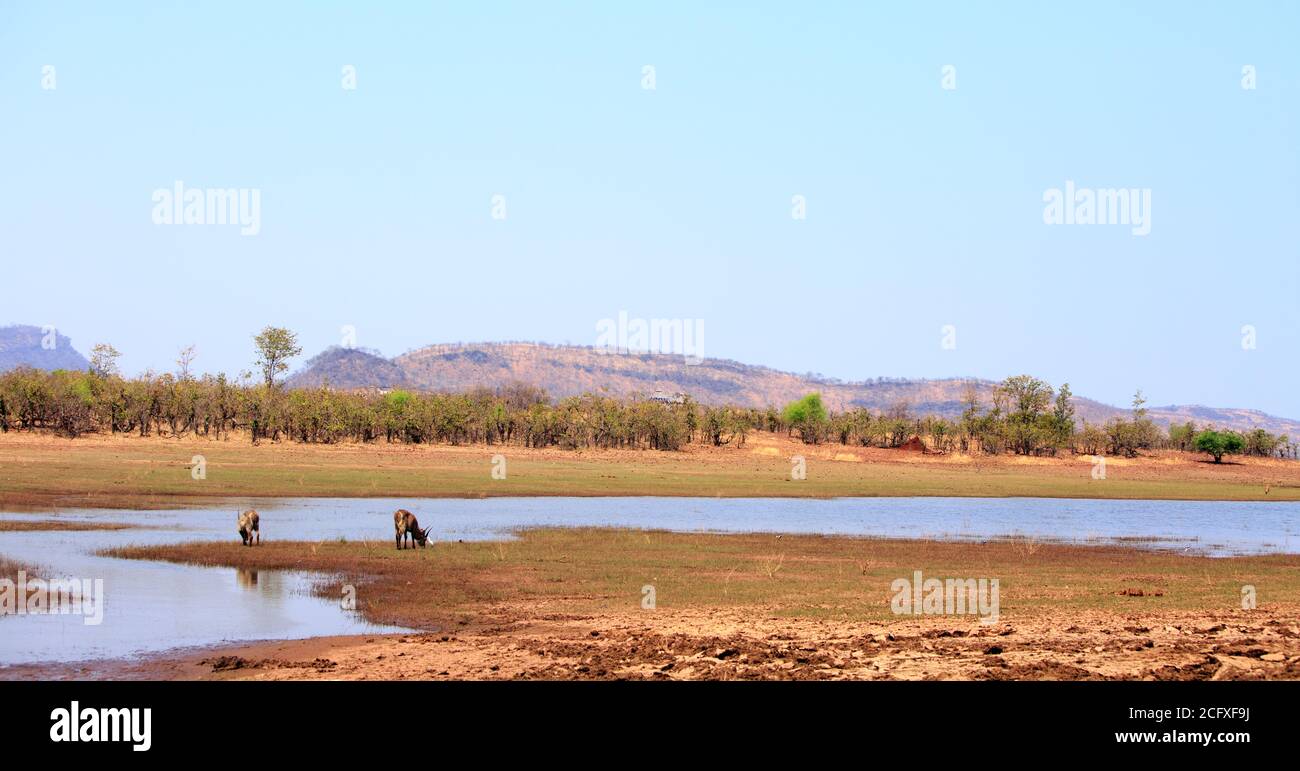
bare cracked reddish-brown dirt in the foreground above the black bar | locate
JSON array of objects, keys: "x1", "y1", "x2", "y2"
[{"x1": 5, "y1": 605, "x2": 1300, "y2": 680}]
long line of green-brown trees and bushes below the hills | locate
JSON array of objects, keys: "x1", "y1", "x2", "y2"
[{"x1": 0, "y1": 328, "x2": 1297, "y2": 460}]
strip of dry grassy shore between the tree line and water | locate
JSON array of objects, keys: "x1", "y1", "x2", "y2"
[{"x1": 0, "y1": 433, "x2": 1300, "y2": 508}]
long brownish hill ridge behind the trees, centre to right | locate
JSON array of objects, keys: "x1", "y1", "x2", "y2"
[{"x1": 289, "y1": 343, "x2": 1300, "y2": 437}]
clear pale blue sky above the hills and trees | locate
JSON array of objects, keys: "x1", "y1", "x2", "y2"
[{"x1": 0, "y1": 1, "x2": 1300, "y2": 416}]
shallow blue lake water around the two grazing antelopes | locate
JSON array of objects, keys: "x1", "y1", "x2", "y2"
[{"x1": 0, "y1": 498, "x2": 1300, "y2": 667}]
